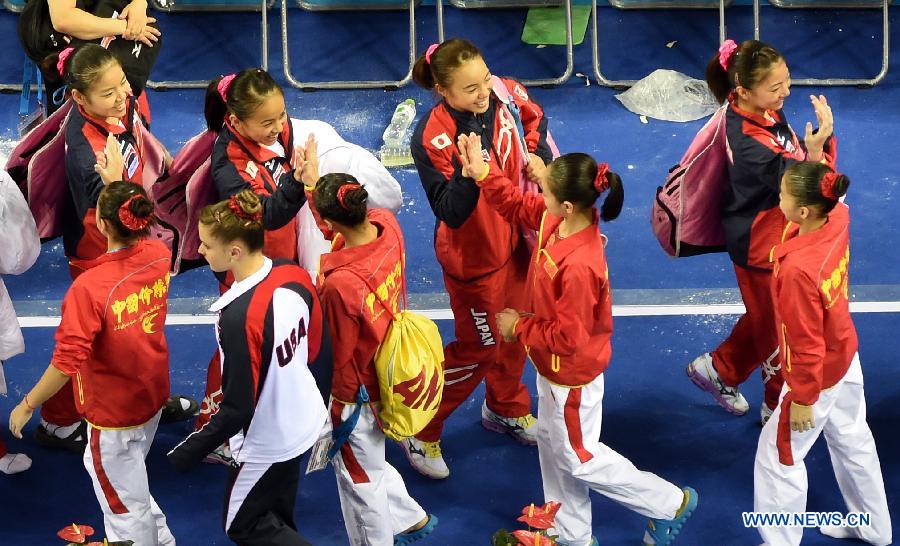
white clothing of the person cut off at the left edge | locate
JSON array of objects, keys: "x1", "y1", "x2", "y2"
[{"x1": 0, "y1": 170, "x2": 41, "y2": 360}]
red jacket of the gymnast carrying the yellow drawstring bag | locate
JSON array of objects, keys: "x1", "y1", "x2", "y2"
[{"x1": 318, "y1": 209, "x2": 406, "y2": 404}]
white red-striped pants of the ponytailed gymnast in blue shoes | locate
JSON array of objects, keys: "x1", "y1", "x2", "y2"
[{"x1": 537, "y1": 374, "x2": 684, "y2": 546}]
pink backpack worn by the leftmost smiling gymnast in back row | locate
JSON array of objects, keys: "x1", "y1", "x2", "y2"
[{"x1": 6, "y1": 99, "x2": 178, "y2": 264}]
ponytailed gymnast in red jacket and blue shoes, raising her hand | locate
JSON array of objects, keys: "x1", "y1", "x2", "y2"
[{"x1": 459, "y1": 141, "x2": 697, "y2": 546}]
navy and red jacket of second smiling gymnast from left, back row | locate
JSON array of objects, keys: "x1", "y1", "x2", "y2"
[{"x1": 212, "y1": 120, "x2": 306, "y2": 263}]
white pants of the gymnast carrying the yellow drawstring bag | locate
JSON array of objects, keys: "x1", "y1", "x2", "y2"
[{"x1": 331, "y1": 400, "x2": 426, "y2": 546}]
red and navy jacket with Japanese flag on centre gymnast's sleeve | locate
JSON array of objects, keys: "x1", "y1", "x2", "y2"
[{"x1": 411, "y1": 79, "x2": 553, "y2": 281}]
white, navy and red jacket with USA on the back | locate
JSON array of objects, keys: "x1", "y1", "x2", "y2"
[{"x1": 168, "y1": 258, "x2": 333, "y2": 469}]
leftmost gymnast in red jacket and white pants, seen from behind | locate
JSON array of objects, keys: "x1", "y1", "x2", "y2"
[{"x1": 9, "y1": 183, "x2": 175, "y2": 545}]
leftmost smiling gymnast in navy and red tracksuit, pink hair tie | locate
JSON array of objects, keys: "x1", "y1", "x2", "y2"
[{"x1": 35, "y1": 44, "x2": 183, "y2": 453}]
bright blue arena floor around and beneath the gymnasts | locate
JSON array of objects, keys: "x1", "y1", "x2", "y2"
[{"x1": 0, "y1": 7, "x2": 900, "y2": 546}]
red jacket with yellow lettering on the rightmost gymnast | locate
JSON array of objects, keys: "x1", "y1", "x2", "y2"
[{"x1": 772, "y1": 203, "x2": 858, "y2": 405}]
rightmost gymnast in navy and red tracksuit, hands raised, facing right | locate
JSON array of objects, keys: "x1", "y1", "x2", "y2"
[{"x1": 687, "y1": 40, "x2": 836, "y2": 423}]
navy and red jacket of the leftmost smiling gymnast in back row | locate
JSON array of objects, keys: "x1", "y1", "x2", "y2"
[{"x1": 63, "y1": 97, "x2": 144, "y2": 260}]
